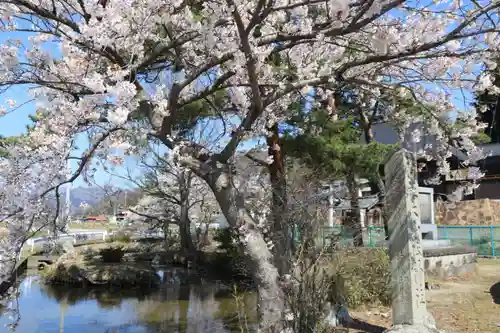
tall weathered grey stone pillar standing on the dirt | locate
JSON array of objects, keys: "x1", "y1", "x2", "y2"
[{"x1": 384, "y1": 149, "x2": 438, "y2": 333}]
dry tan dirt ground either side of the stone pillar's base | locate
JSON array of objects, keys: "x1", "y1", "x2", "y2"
[{"x1": 348, "y1": 259, "x2": 500, "y2": 333}]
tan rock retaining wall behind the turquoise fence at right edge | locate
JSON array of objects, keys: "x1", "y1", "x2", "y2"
[{"x1": 435, "y1": 199, "x2": 500, "y2": 225}]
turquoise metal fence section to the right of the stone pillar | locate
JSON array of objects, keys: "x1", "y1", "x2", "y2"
[{"x1": 438, "y1": 225, "x2": 500, "y2": 257}]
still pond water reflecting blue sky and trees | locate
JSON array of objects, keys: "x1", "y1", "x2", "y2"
[{"x1": 0, "y1": 269, "x2": 257, "y2": 333}]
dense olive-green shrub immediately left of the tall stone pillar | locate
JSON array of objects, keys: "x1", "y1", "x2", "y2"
[{"x1": 329, "y1": 248, "x2": 391, "y2": 308}]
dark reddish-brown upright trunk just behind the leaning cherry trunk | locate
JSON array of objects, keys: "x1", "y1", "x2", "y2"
[{"x1": 267, "y1": 124, "x2": 293, "y2": 275}]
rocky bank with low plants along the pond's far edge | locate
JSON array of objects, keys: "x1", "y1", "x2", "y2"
[{"x1": 41, "y1": 242, "x2": 252, "y2": 287}]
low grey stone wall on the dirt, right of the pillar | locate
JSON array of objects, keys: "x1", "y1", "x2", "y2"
[{"x1": 424, "y1": 253, "x2": 477, "y2": 278}]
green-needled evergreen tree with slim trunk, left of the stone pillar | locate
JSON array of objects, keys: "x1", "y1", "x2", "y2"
[{"x1": 283, "y1": 103, "x2": 395, "y2": 246}]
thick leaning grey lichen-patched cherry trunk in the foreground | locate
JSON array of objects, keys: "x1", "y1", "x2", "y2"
[{"x1": 207, "y1": 172, "x2": 284, "y2": 333}]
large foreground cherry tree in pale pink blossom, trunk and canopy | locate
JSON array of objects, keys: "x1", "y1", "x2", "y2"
[{"x1": 0, "y1": 0, "x2": 500, "y2": 331}]
